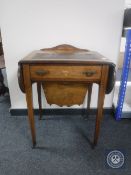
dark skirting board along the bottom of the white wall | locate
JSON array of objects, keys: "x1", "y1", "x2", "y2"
[{"x1": 10, "y1": 108, "x2": 113, "y2": 116}]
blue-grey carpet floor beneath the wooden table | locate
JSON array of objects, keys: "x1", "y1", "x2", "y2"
[{"x1": 0, "y1": 97, "x2": 131, "y2": 175}]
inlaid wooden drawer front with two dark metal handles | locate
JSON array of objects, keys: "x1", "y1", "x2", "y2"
[{"x1": 30, "y1": 65, "x2": 101, "y2": 81}]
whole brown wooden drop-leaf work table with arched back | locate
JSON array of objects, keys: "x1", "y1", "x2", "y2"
[{"x1": 18, "y1": 44, "x2": 115, "y2": 146}]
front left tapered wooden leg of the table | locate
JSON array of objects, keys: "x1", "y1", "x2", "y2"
[{"x1": 23, "y1": 65, "x2": 36, "y2": 147}]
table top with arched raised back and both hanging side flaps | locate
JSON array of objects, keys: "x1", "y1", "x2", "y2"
[{"x1": 18, "y1": 44, "x2": 115, "y2": 93}]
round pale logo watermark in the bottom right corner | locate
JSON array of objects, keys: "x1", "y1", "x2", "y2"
[{"x1": 106, "y1": 150, "x2": 124, "y2": 168}]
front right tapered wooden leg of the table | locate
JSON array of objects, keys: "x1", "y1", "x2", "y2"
[{"x1": 94, "y1": 66, "x2": 108, "y2": 146}]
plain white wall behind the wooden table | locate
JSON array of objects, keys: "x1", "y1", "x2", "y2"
[{"x1": 0, "y1": 0, "x2": 124, "y2": 108}]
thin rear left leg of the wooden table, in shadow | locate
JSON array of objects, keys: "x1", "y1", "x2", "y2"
[{"x1": 37, "y1": 82, "x2": 42, "y2": 120}]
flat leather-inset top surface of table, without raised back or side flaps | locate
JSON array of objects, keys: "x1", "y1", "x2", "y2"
[{"x1": 19, "y1": 50, "x2": 113, "y2": 64}]
